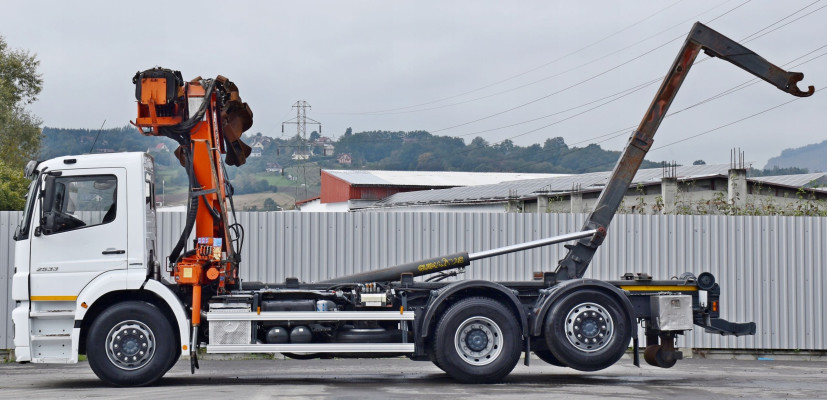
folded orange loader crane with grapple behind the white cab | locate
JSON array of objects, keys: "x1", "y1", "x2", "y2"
[{"x1": 132, "y1": 68, "x2": 253, "y2": 364}]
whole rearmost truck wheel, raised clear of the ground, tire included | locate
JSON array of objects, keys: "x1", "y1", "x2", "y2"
[{"x1": 545, "y1": 289, "x2": 632, "y2": 371}]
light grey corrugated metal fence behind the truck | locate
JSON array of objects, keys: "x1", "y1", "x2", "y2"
[{"x1": 0, "y1": 212, "x2": 827, "y2": 350}]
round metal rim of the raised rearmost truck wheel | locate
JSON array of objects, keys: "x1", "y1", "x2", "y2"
[{"x1": 565, "y1": 303, "x2": 614, "y2": 353}]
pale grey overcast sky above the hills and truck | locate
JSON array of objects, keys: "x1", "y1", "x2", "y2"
[{"x1": 0, "y1": 0, "x2": 827, "y2": 167}]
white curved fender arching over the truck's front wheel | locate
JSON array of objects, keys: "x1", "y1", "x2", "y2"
[{"x1": 72, "y1": 269, "x2": 190, "y2": 354}]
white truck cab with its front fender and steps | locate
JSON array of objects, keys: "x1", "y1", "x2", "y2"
[{"x1": 12, "y1": 153, "x2": 189, "y2": 363}]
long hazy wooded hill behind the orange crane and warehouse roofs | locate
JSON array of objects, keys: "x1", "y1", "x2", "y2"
[{"x1": 40, "y1": 126, "x2": 660, "y2": 174}]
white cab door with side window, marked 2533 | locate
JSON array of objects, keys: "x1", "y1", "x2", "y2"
[{"x1": 29, "y1": 168, "x2": 128, "y2": 301}]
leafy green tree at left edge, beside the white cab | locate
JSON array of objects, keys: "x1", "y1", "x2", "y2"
[{"x1": 0, "y1": 36, "x2": 43, "y2": 210}]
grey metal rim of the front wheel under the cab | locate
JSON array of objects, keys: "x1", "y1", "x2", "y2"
[{"x1": 106, "y1": 320, "x2": 155, "y2": 371}]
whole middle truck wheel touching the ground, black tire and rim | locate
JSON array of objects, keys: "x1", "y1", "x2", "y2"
[{"x1": 433, "y1": 297, "x2": 522, "y2": 383}]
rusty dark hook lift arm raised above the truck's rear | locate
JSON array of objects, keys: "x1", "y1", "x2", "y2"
[{"x1": 555, "y1": 22, "x2": 815, "y2": 281}]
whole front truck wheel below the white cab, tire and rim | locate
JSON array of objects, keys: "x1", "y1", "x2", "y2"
[{"x1": 86, "y1": 301, "x2": 178, "y2": 386}]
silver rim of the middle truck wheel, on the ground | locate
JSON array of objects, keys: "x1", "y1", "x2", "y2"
[{"x1": 454, "y1": 317, "x2": 503, "y2": 366}]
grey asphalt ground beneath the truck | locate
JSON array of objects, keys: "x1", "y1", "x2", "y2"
[{"x1": 0, "y1": 359, "x2": 827, "y2": 400}]
